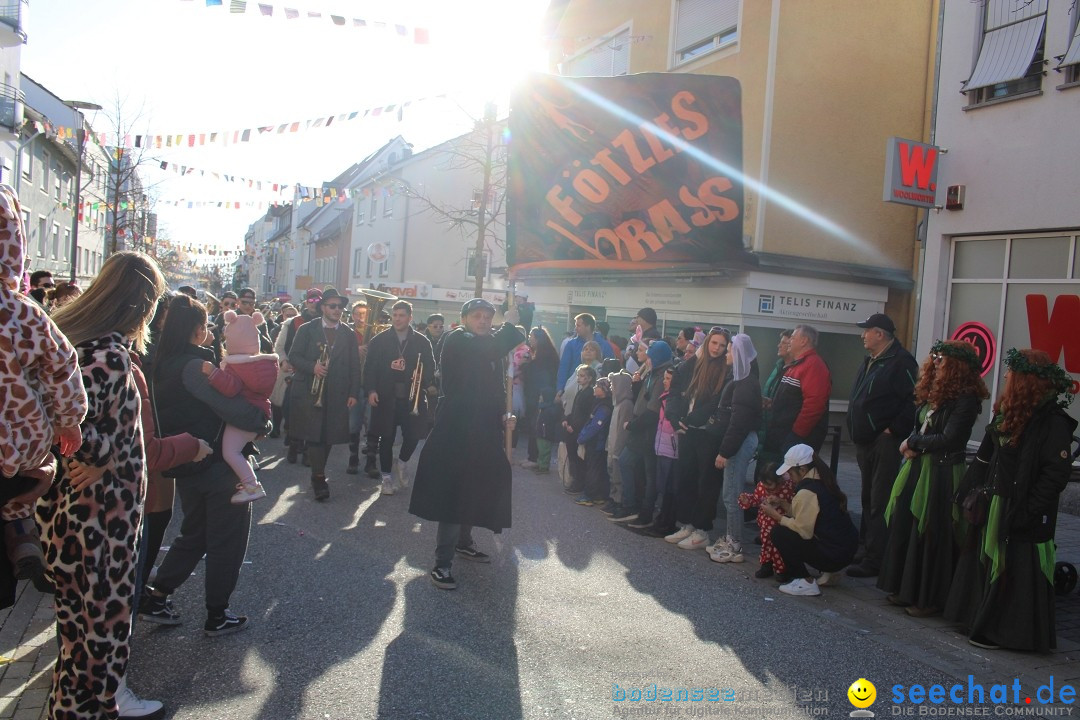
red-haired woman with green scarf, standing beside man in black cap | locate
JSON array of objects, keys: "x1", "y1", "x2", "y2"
[{"x1": 877, "y1": 340, "x2": 989, "y2": 617}]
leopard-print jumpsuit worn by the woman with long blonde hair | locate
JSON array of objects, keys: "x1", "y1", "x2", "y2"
[{"x1": 38, "y1": 334, "x2": 146, "y2": 720}]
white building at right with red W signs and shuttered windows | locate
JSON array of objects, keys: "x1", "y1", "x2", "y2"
[{"x1": 917, "y1": 0, "x2": 1080, "y2": 431}]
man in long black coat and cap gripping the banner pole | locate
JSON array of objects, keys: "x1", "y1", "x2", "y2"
[{"x1": 409, "y1": 298, "x2": 525, "y2": 589}]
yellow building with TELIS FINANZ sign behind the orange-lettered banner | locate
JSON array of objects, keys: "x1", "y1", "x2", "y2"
[{"x1": 524, "y1": 0, "x2": 937, "y2": 411}]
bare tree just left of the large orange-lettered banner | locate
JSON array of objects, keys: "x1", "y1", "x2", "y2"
[{"x1": 404, "y1": 104, "x2": 507, "y2": 298}]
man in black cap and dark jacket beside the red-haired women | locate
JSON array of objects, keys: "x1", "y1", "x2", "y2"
[{"x1": 848, "y1": 313, "x2": 919, "y2": 578}]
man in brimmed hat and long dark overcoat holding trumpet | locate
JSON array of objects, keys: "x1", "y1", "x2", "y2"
[{"x1": 288, "y1": 287, "x2": 360, "y2": 500}]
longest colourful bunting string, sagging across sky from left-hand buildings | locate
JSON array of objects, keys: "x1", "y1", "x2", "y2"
[{"x1": 46, "y1": 93, "x2": 447, "y2": 150}]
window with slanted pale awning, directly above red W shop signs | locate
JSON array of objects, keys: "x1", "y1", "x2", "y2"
[{"x1": 963, "y1": 0, "x2": 1047, "y2": 105}]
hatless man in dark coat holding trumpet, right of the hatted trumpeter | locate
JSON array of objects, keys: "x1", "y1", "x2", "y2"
[{"x1": 353, "y1": 300, "x2": 436, "y2": 495}]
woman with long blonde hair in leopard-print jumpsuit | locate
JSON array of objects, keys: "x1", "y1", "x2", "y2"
[{"x1": 38, "y1": 253, "x2": 165, "y2": 718}]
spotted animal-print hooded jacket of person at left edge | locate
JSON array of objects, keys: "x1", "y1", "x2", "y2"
[{"x1": 0, "y1": 185, "x2": 86, "y2": 477}]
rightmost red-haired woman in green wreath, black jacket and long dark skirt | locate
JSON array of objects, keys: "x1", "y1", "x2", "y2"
[{"x1": 945, "y1": 349, "x2": 1077, "y2": 652}]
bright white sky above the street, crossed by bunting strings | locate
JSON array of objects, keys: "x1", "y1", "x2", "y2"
[{"x1": 22, "y1": 0, "x2": 548, "y2": 259}]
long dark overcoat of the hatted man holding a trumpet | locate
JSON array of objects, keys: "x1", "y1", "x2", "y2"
[{"x1": 288, "y1": 317, "x2": 363, "y2": 445}]
